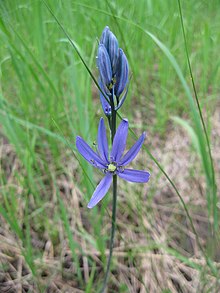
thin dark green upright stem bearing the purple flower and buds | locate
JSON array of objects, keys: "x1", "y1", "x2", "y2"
[{"x1": 100, "y1": 92, "x2": 117, "y2": 293}]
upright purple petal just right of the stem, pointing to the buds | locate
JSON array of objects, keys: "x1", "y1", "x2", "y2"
[{"x1": 110, "y1": 119, "x2": 128, "y2": 162}]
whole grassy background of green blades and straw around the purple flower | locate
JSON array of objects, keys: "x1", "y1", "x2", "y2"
[{"x1": 0, "y1": 0, "x2": 220, "y2": 292}]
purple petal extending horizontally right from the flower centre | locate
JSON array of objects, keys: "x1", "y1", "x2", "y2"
[{"x1": 117, "y1": 169, "x2": 150, "y2": 183}]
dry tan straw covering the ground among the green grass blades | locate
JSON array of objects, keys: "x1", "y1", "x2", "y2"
[{"x1": 0, "y1": 111, "x2": 220, "y2": 293}]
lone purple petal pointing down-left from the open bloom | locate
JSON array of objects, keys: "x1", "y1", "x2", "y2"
[{"x1": 87, "y1": 174, "x2": 112, "y2": 209}]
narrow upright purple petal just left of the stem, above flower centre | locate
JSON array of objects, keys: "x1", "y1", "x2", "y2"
[{"x1": 97, "y1": 118, "x2": 108, "y2": 164}]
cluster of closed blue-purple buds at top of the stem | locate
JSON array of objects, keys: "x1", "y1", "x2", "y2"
[{"x1": 97, "y1": 26, "x2": 129, "y2": 116}]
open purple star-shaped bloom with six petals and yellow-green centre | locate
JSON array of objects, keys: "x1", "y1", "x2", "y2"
[{"x1": 76, "y1": 118, "x2": 150, "y2": 208}]
